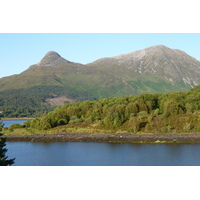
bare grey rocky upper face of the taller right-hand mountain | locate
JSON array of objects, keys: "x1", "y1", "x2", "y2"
[{"x1": 90, "y1": 45, "x2": 200, "y2": 87}]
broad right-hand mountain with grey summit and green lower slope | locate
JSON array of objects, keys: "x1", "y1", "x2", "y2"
[{"x1": 90, "y1": 45, "x2": 200, "y2": 94}]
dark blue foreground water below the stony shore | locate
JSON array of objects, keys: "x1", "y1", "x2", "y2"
[{"x1": 6, "y1": 142, "x2": 200, "y2": 166}]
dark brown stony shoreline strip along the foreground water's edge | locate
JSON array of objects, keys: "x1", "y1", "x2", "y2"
[{"x1": 3, "y1": 133, "x2": 200, "y2": 144}]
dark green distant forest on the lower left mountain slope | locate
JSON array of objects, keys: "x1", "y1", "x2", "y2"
[{"x1": 0, "y1": 85, "x2": 94, "y2": 118}]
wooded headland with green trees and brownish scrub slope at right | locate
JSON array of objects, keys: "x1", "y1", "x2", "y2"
[{"x1": 20, "y1": 86, "x2": 200, "y2": 133}]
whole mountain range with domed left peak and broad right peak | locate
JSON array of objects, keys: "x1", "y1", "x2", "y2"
[{"x1": 0, "y1": 45, "x2": 200, "y2": 117}]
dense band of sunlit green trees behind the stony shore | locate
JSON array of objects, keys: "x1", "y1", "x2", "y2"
[{"x1": 27, "y1": 86, "x2": 200, "y2": 132}]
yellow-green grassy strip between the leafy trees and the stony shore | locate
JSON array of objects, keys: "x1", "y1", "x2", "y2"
[{"x1": 2, "y1": 119, "x2": 199, "y2": 136}]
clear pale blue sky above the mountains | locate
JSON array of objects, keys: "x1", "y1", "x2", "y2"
[{"x1": 0, "y1": 33, "x2": 200, "y2": 77}]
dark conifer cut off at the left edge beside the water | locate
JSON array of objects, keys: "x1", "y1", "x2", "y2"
[{"x1": 0, "y1": 122, "x2": 15, "y2": 166}]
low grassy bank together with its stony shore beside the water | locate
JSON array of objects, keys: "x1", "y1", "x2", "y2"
[{"x1": 3, "y1": 119, "x2": 200, "y2": 144}]
